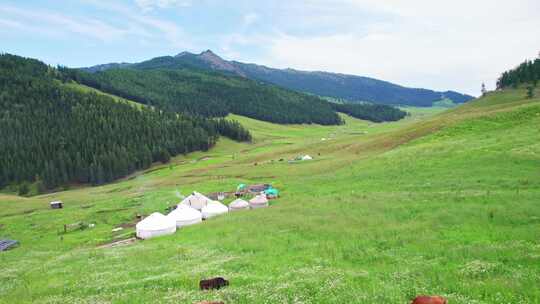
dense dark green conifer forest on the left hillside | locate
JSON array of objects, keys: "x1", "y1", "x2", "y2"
[{"x1": 0, "y1": 54, "x2": 251, "y2": 191}]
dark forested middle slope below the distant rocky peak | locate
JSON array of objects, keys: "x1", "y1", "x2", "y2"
[{"x1": 61, "y1": 68, "x2": 341, "y2": 125}]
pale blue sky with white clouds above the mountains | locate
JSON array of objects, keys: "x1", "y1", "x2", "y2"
[{"x1": 0, "y1": 0, "x2": 540, "y2": 96}]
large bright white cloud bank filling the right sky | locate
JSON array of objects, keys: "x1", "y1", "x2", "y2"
[{"x1": 252, "y1": 0, "x2": 540, "y2": 95}]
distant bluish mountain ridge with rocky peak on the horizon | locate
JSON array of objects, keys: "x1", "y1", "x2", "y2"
[{"x1": 85, "y1": 50, "x2": 473, "y2": 107}]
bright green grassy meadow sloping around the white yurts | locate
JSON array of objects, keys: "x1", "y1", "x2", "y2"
[{"x1": 0, "y1": 89, "x2": 540, "y2": 303}]
